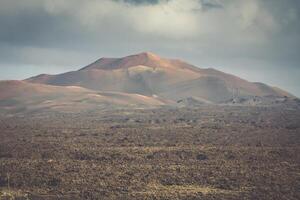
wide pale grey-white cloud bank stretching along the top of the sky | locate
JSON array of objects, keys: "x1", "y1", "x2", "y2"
[{"x1": 41, "y1": 0, "x2": 284, "y2": 42}]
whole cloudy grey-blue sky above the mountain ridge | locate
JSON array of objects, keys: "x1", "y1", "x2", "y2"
[{"x1": 0, "y1": 0, "x2": 300, "y2": 97}]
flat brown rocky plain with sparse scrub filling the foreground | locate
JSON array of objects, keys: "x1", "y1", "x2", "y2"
[{"x1": 0, "y1": 105, "x2": 300, "y2": 200}]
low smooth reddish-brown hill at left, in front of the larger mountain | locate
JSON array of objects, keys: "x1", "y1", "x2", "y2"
[{"x1": 0, "y1": 81, "x2": 167, "y2": 113}]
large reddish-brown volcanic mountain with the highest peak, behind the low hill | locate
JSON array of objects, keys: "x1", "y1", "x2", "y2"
[{"x1": 26, "y1": 52, "x2": 290, "y2": 103}]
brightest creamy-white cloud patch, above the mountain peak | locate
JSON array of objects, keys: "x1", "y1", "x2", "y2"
[{"x1": 129, "y1": 0, "x2": 201, "y2": 38}]
